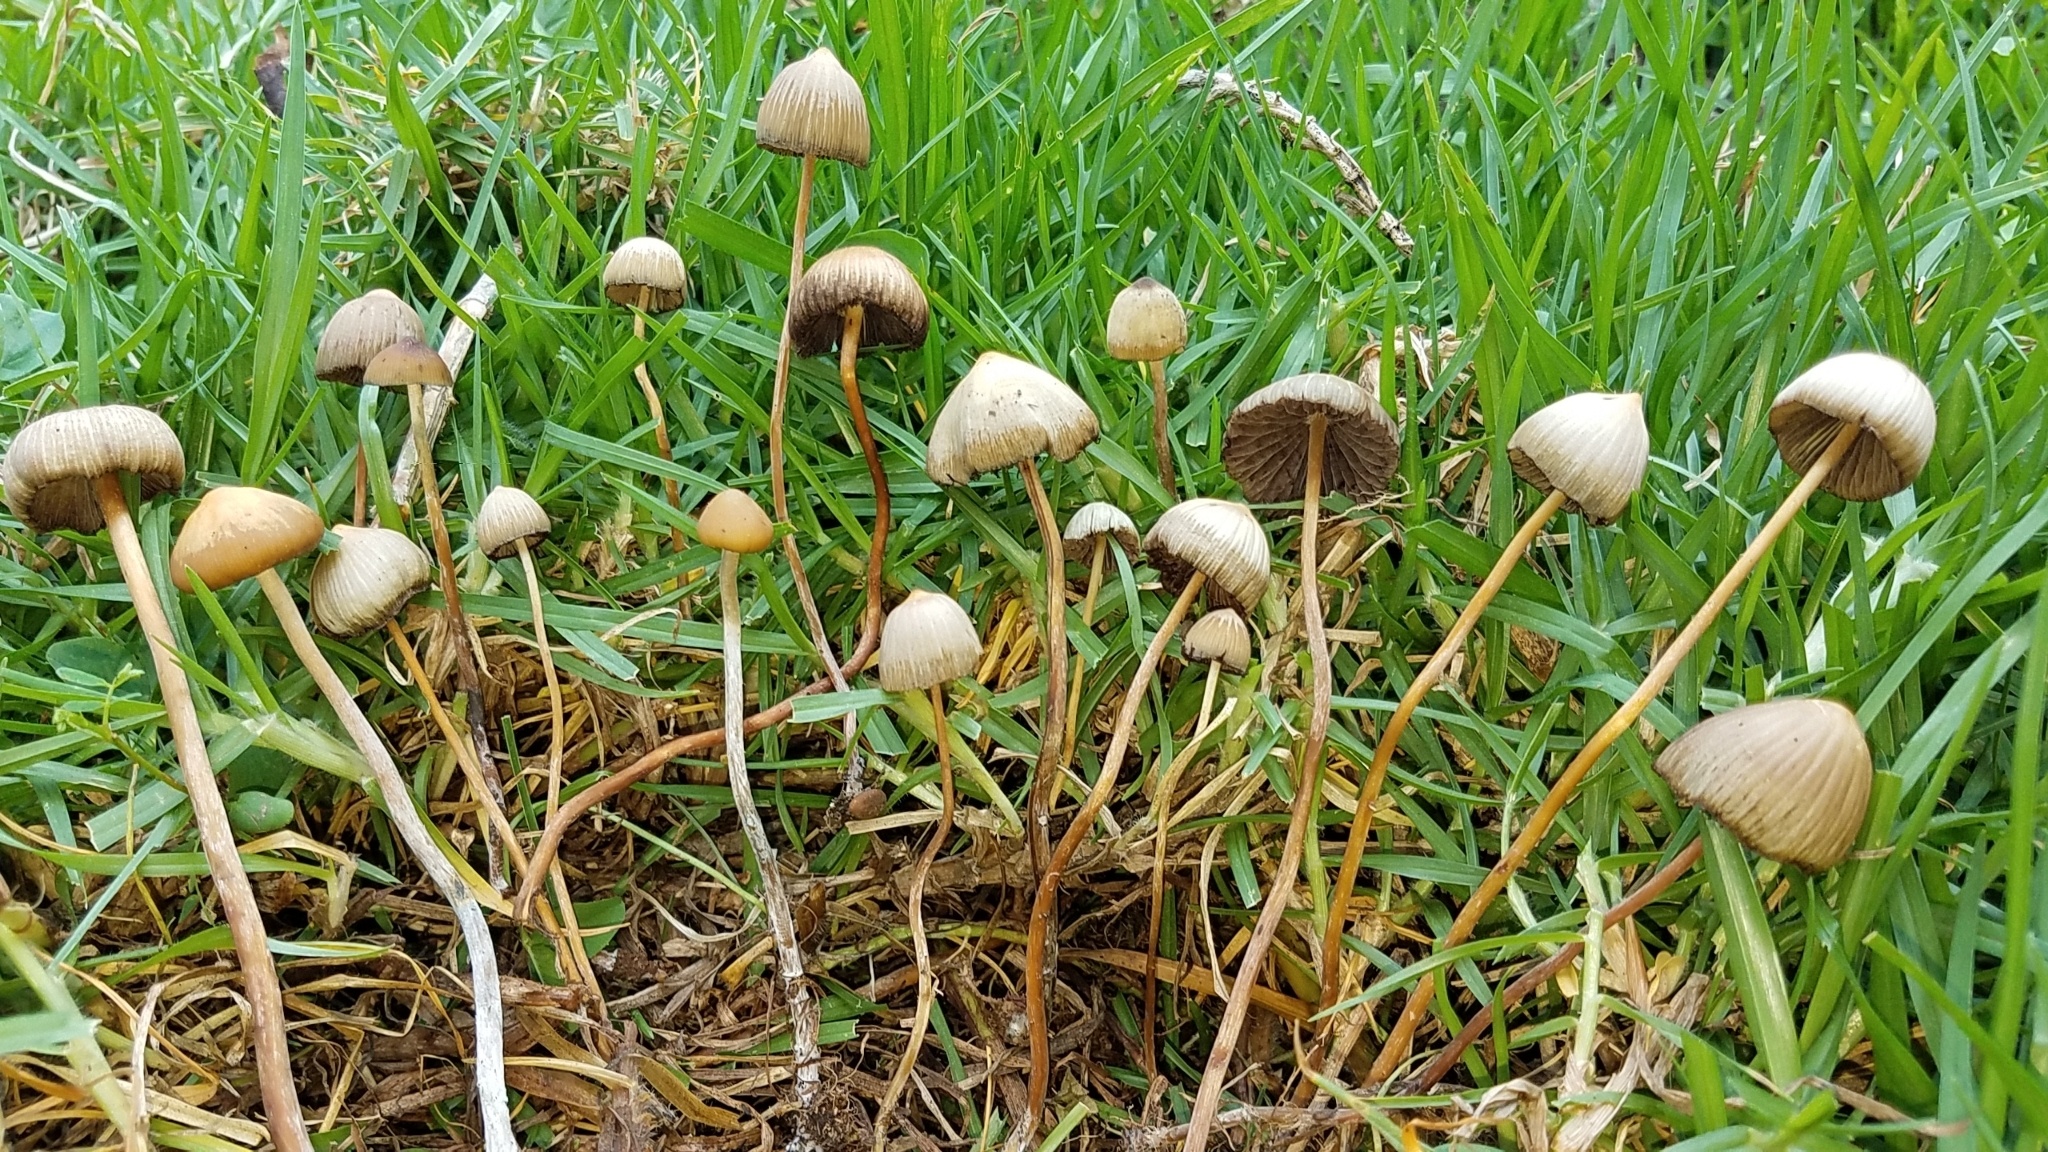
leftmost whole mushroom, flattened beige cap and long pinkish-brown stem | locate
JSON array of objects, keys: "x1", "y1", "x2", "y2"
[{"x1": 0, "y1": 404, "x2": 311, "y2": 1152}]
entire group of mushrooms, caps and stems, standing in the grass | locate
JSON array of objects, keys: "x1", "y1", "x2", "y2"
[{"x1": 0, "y1": 35, "x2": 1933, "y2": 1152}]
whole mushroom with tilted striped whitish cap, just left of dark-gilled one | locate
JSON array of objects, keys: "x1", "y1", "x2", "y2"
[{"x1": 1018, "y1": 498, "x2": 1272, "y2": 1144}]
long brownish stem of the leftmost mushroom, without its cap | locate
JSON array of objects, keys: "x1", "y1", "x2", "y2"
[{"x1": 92, "y1": 476, "x2": 313, "y2": 1152}]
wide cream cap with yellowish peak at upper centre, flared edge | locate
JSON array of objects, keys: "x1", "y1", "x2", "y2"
[{"x1": 924, "y1": 353, "x2": 1102, "y2": 484}]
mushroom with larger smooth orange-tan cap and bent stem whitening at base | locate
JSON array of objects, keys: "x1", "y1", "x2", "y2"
[{"x1": 170, "y1": 488, "x2": 518, "y2": 1152}]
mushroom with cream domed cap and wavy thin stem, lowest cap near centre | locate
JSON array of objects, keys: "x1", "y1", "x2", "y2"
[{"x1": 874, "y1": 592, "x2": 981, "y2": 1142}]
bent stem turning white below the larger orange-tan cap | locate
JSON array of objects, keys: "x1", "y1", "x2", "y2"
[{"x1": 256, "y1": 568, "x2": 518, "y2": 1152}]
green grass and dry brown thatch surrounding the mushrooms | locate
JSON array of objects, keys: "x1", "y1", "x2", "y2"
[{"x1": 0, "y1": 0, "x2": 2048, "y2": 1148}]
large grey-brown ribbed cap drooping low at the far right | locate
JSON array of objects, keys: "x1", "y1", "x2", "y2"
[{"x1": 1657, "y1": 699, "x2": 1870, "y2": 871}]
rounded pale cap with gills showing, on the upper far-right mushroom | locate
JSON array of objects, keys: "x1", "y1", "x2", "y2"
[{"x1": 1772, "y1": 344, "x2": 1933, "y2": 500}]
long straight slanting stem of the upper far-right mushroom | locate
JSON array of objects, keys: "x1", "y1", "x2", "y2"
[{"x1": 1359, "y1": 422, "x2": 1864, "y2": 1082}]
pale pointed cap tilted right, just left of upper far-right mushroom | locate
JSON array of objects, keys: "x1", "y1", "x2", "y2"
[{"x1": 1507, "y1": 392, "x2": 1651, "y2": 525}]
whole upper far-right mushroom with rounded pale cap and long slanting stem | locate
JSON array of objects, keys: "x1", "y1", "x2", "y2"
[{"x1": 1368, "y1": 353, "x2": 1935, "y2": 1084}]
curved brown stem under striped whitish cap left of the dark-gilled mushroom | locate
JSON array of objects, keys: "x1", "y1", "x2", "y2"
[{"x1": 1018, "y1": 573, "x2": 1206, "y2": 1146}]
